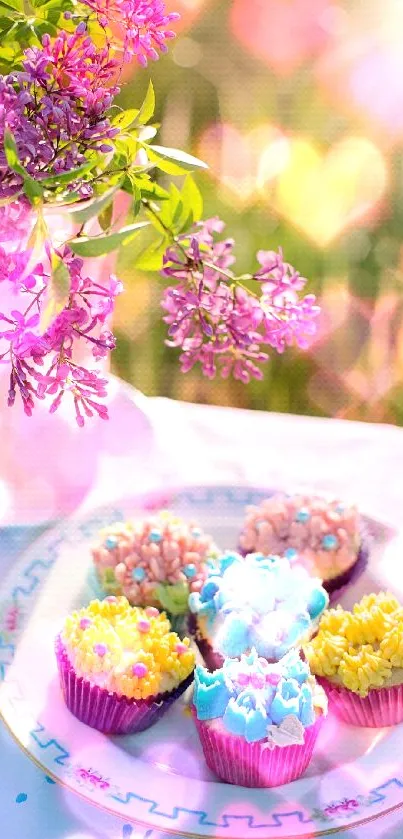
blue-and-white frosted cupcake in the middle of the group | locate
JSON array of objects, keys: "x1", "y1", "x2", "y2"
[{"x1": 189, "y1": 552, "x2": 329, "y2": 669}]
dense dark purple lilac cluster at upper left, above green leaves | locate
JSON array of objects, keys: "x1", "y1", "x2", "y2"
[{"x1": 0, "y1": 23, "x2": 118, "y2": 198}]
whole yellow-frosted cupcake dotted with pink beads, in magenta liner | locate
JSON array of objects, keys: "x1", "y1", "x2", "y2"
[{"x1": 56, "y1": 596, "x2": 195, "y2": 734}]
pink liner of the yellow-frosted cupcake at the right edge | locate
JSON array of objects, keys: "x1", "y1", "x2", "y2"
[{"x1": 316, "y1": 676, "x2": 403, "y2": 728}]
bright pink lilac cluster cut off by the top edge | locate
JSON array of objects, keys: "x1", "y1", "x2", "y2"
[{"x1": 82, "y1": 0, "x2": 179, "y2": 67}]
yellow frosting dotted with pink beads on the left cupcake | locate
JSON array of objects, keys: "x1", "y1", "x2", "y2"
[{"x1": 60, "y1": 596, "x2": 195, "y2": 699}]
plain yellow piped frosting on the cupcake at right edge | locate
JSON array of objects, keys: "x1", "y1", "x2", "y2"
[{"x1": 304, "y1": 592, "x2": 403, "y2": 697}]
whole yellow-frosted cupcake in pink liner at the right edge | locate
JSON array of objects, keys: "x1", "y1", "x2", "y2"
[{"x1": 304, "y1": 592, "x2": 403, "y2": 728}]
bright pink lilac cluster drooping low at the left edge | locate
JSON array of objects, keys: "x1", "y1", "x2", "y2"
[{"x1": 0, "y1": 220, "x2": 122, "y2": 426}]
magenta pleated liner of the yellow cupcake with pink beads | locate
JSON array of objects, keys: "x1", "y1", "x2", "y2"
[{"x1": 55, "y1": 635, "x2": 193, "y2": 734}]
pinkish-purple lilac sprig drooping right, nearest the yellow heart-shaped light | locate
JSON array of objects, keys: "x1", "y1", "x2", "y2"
[{"x1": 162, "y1": 219, "x2": 319, "y2": 382}]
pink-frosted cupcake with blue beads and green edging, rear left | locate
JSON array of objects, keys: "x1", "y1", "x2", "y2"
[{"x1": 92, "y1": 512, "x2": 217, "y2": 615}]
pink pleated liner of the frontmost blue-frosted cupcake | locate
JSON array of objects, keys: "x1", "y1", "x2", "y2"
[{"x1": 193, "y1": 708, "x2": 323, "y2": 787}]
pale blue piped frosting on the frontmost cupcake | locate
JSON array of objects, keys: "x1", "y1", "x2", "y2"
[{"x1": 193, "y1": 649, "x2": 327, "y2": 748}]
